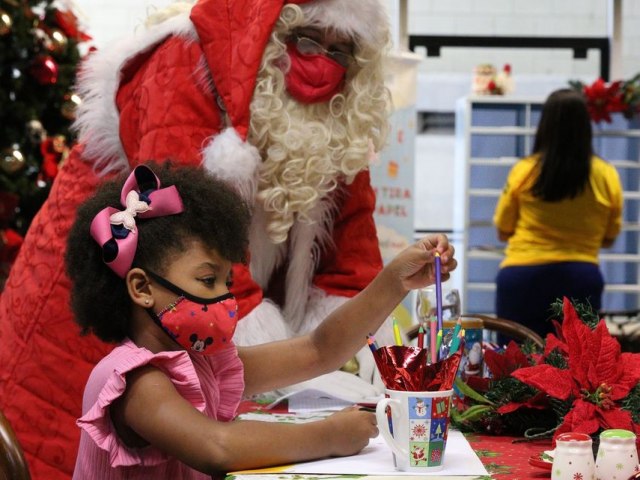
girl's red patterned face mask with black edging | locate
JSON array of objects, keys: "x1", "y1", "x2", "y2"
[{"x1": 147, "y1": 270, "x2": 238, "y2": 355}]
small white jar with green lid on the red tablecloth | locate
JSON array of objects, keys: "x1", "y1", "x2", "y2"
[{"x1": 596, "y1": 429, "x2": 638, "y2": 480}]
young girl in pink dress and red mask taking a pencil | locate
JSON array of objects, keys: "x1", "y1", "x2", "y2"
[{"x1": 66, "y1": 165, "x2": 456, "y2": 480}]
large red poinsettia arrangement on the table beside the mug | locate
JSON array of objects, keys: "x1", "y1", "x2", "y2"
[{"x1": 452, "y1": 298, "x2": 640, "y2": 443}]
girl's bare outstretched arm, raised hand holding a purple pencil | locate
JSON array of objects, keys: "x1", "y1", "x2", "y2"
[{"x1": 238, "y1": 235, "x2": 456, "y2": 394}]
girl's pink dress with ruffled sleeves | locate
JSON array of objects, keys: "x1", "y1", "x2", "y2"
[{"x1": 73, "y1": 340, "x2": 244, "y2": 480}]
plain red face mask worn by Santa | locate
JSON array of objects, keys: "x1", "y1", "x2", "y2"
[{"x1": 285, "y1": 43, "x2": 347, "y2": 103}]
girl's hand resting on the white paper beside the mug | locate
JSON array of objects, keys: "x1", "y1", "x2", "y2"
[{"x1": 325, "y1": 406, "x2": 378, "y2": 457}]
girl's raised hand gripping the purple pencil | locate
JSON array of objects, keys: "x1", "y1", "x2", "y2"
[{"x1": 391, "y1": 234, "x2": 458, "y2": 290}]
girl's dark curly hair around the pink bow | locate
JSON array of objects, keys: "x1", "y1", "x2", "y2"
[{"x1": 65, "y1": 163, "x2": 250, "y2": 342}]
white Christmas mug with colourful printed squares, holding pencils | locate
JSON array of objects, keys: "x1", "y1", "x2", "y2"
[{"x1": 376, "y1": 389, "x2": 453, "y2": 473}]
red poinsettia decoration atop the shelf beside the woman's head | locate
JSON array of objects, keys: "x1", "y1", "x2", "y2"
[{"x1": 569, "y1": 73, "x2": 640, "y2": 123}]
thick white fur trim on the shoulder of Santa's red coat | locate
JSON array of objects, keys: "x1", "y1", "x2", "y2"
[{"x1": 74, "y1": 13, "x2": 197, "y2": 171}]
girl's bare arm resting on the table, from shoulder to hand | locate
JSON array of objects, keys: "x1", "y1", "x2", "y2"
[{"x1": 117, "y1": 366, "x2": 378, "y2": 474}]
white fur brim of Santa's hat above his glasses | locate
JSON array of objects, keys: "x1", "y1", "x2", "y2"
[{"x1": 300, "y1": 0, "x2": 389, "y2": 49}]
